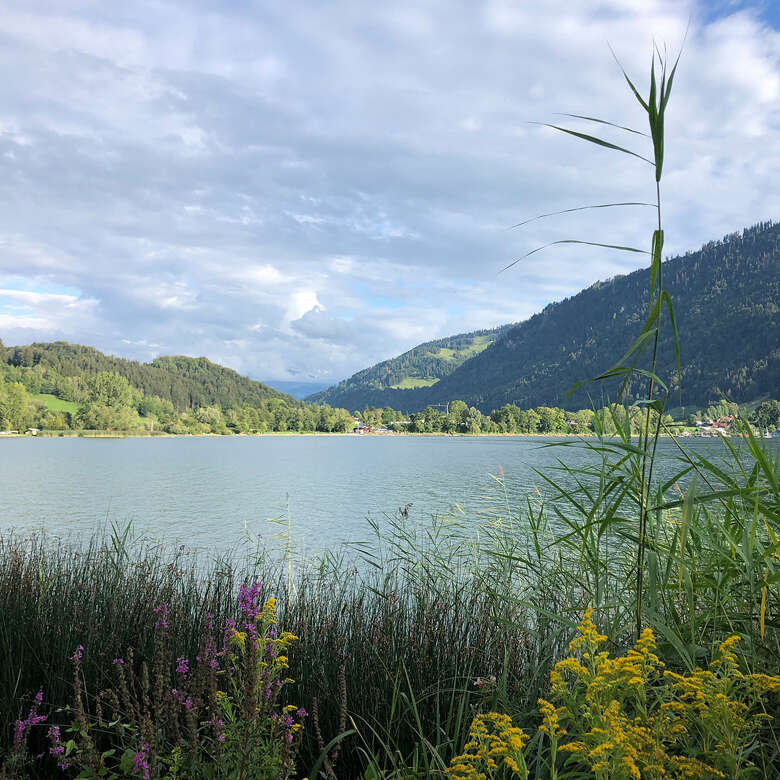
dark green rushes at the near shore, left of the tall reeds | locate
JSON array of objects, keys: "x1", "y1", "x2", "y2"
[{"x1": 0, "y1": 519, "x2": 561, "y2": 777}]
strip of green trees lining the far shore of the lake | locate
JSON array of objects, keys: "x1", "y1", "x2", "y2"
[{"x1": 0, "y1": 367, "x2": 780, "y2": 436}]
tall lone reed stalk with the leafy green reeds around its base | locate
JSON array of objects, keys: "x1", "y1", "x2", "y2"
[{"x1": 508, "y1": 39, "x2": 780, "y2": 684}]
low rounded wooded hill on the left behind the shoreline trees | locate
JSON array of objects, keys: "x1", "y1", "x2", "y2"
[{"x1": 0, "y1": 341, "x2": 292, "y2": 411}]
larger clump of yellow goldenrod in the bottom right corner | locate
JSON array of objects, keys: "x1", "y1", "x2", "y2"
[{"x1": 552, "y1": 610, "x2": 780, "y2": 780}]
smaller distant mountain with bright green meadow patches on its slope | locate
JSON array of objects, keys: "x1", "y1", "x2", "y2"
[{"x1": 306, "y1": 325, "x2": 513, "y2": 404}]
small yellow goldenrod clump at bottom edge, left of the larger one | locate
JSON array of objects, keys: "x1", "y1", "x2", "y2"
[{"x1": 447, "y1": 712, "x2": 528, "y2": 780}]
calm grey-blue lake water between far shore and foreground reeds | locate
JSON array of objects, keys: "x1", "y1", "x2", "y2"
[{"x1": 0, "y1": 436, "x2": 744, "y2": 552}]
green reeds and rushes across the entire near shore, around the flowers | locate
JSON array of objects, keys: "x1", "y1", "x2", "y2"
[{"x1": 0, "y1": 420, "x2": 780, "y2": 778}]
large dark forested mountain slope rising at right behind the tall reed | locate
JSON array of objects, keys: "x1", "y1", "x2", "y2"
[{"x1": 310, "y1": 222, "x2": 780, "y2": 412}]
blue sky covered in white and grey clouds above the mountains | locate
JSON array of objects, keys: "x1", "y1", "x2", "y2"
[{"x1": 0, "y1": 0, "x2": 780, "y2": 390}]
